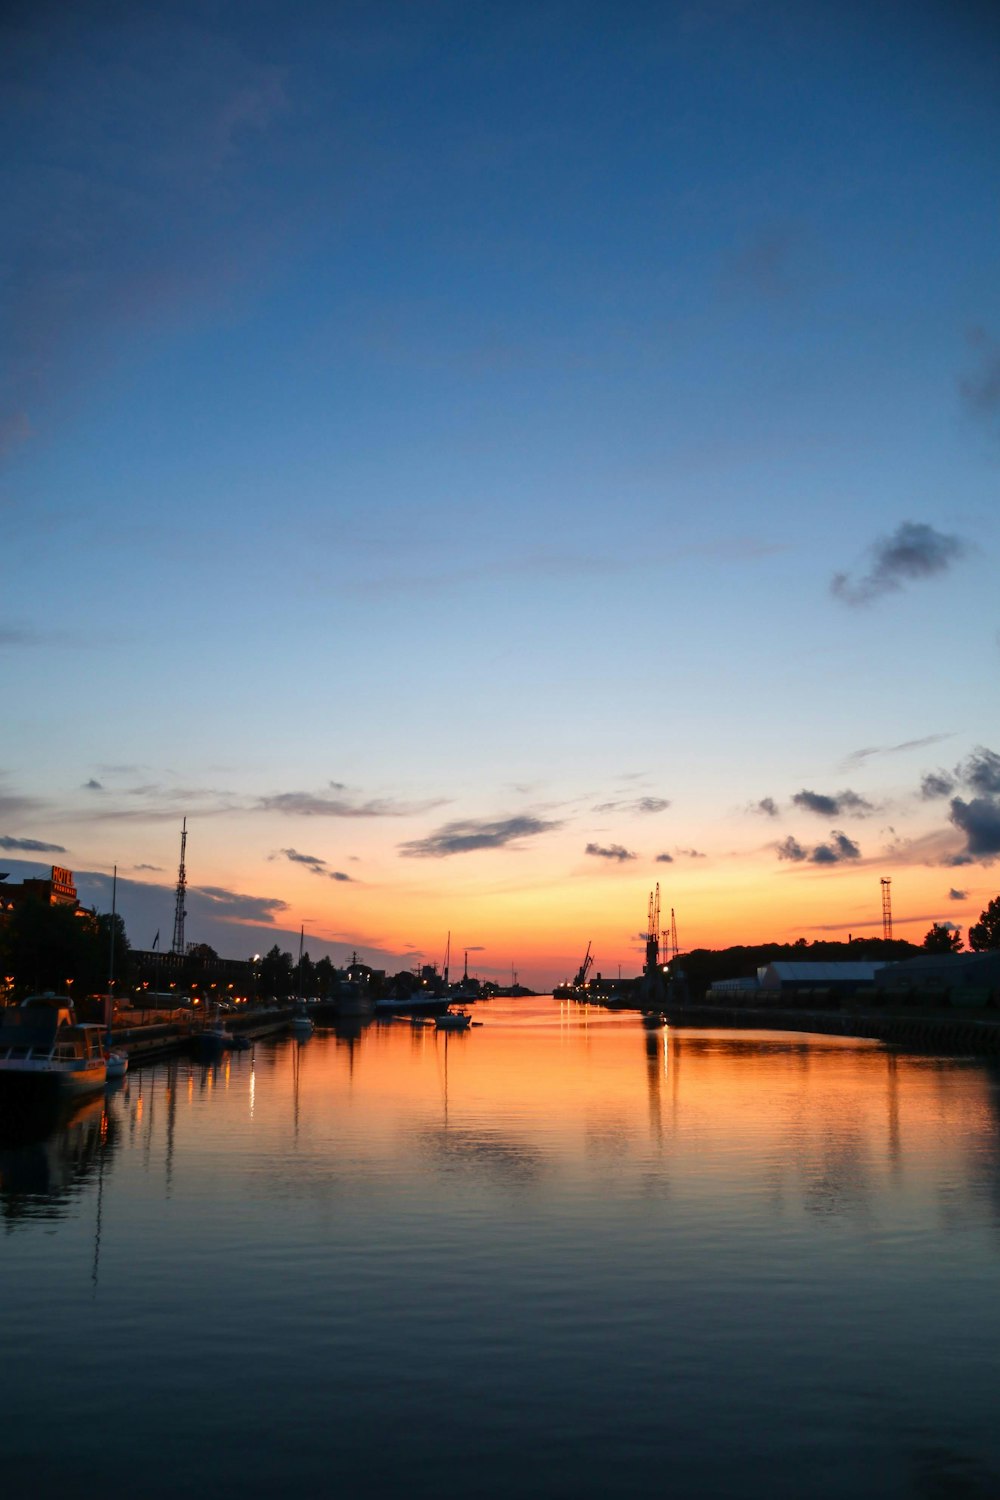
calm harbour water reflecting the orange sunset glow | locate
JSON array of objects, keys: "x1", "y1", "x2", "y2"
[{"x1": 0, "y1": 1001, "x2": 1000, "y2": 1500}]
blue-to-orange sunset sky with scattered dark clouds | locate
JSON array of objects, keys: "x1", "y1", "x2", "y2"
[{"x1": 0, "y1": 0, "x2": 1000, "y2": 989}]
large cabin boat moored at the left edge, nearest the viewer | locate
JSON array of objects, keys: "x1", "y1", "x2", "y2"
[{"x1": 0, "y1": 993, "x2": 108, "y2": 1100}]
